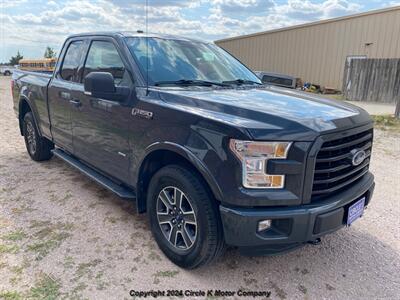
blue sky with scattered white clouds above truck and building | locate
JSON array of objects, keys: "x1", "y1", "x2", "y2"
[{"x1": 0, "y1": 0, "x2": 400, "y2": 62}]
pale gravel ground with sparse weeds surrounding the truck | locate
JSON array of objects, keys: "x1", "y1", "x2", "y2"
[{"x1": 0, "y1": 77, "x2": 400, "y2": 299}]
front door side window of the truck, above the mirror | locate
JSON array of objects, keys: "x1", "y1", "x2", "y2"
[{"x1": 83, "y1": 41, "x2": 131, "y2": 86}]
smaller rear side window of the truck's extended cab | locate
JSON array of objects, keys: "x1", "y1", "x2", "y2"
[{"x1": 60, "y1": 41, "x2": 83, "y2": 82}]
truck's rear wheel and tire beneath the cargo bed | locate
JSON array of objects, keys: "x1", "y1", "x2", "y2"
[{"x1": 22, "y1": 112, "x2": 54, "y2": 161}]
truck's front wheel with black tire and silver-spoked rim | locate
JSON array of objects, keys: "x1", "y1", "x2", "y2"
[{"x1": 147, "y1": 165, "x2": 224, "y2": 269}]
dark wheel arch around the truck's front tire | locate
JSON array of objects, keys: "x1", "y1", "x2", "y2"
[{"x1": 136, "y1": 142, "x2": 222, "y2": 213}]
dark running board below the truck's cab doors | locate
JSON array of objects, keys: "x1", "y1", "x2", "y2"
[{"x1": 52, "y1": 149, "x2": 136, "y2": 199}]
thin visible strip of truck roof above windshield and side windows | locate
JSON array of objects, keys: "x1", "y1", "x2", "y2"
[{"x1": 68, "y1": 31, "x2": 209, "y2": 43}]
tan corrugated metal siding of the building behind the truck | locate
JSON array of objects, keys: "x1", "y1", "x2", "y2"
[{"x1": 216, "y1": 7, "x2": 400, "y2": 89}]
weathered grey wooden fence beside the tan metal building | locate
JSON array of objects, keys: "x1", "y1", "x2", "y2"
[{"x1": 343, "y1": 58, "x2": 400, "y2": 103}]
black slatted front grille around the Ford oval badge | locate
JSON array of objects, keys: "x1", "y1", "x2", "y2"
[{"x1": 312, "y1": 129, "x2": 373, "y2": 200}]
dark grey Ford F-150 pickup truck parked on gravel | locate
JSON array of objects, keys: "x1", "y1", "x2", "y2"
[{"x1": 11, "y1": 32, "x2": 374, "y2": 268}]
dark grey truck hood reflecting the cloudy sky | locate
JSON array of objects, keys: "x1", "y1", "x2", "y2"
[{"x1": 158, "y1": 86, "x2": 371, "y2": 140}]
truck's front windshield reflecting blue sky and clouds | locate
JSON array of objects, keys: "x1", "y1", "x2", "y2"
[{"x1": 126, "y1": 37, "x2": 261, "y2": 86}]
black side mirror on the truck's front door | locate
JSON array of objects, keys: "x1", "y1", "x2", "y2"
[{"x1": 83, "y1": 72, "x2": 129, "y2": 101}]
